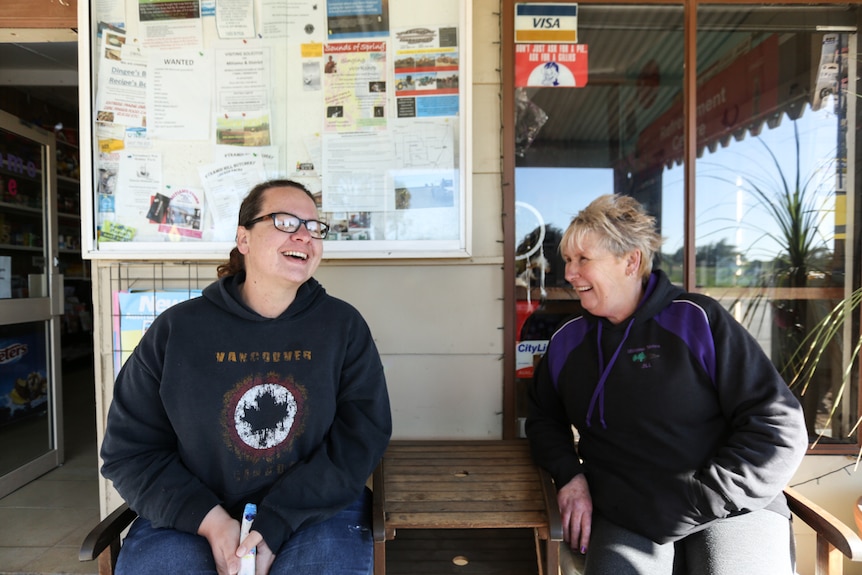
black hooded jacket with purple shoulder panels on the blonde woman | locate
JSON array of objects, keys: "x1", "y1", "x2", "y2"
[{"x1": 527, "y1": 271, "x2": 808, "y2": 543}]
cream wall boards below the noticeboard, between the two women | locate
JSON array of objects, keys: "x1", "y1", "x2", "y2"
[{"x1": 317, "y1": 263, "x2": 502, "y2": 439}]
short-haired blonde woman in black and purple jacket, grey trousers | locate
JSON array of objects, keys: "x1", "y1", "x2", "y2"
[{"x1": 526, "y1": 195, "x2": 808, "y2": 575}]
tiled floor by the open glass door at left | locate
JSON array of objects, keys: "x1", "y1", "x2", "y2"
[{"x1": 0, "y1": 358, "x2": 99, "y2": 575}]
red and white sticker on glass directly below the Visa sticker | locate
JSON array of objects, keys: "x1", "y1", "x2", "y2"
[{"x1": 515, "y1": 44, "x2": 589, "y2": 88}]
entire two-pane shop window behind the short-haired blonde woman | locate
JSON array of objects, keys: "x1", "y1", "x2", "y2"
[{"x1": 504, "y1": 2, "x2": 860, "y2": 451}]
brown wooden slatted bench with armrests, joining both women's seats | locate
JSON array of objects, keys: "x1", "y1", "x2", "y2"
[{"x1": 79, "y1": 440, "x2": 862, "y2": 575}]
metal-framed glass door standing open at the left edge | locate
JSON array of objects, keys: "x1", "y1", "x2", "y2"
[{"x1": 0, "y1": 111, "x2": 63, "y2": 497}]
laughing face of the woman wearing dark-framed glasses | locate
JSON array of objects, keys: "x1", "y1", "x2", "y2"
[{"x1": 237, "y1": 186, "x2": 323, "y2": 293}]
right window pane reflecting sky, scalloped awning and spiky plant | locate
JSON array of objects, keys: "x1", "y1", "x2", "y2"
[{"x1": 695, "y1": 12, "x2": 858, "y2": 443}]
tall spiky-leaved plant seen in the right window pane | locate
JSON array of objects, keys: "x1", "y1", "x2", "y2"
[{"x1": 704, "y1": 118, "x2": 862, "y2": 446}]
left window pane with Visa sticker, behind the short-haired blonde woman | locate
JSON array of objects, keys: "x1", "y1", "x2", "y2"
[{"x1": 513, "y1": 1, "x2": 684, "y2": 435}]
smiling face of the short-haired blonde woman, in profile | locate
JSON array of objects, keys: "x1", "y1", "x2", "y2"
[{"x1": 562, "y1": 233, "x2": 641, "y2": 324}]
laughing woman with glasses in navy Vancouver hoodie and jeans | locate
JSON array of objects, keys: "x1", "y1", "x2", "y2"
[{"x1": 101, "y1": 180, "x2": 392, "y2": 575}]
